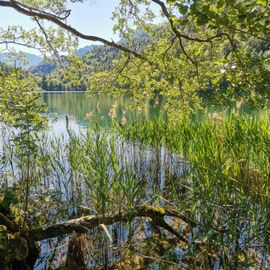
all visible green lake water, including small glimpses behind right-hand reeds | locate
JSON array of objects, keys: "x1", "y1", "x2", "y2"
[{"x1": 42, "y1": 92, "x2": 270, "y2": 131}]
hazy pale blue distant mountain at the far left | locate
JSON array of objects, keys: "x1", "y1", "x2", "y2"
[{"x1": 0, "y1": 53, "x2": 42, "y2": 69}]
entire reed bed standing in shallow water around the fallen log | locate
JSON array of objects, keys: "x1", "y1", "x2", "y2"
[{"x1": 0, "y1": 114, "x2": 270, "y2": 269}]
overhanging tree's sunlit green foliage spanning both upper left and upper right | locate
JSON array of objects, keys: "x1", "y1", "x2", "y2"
[{"x1": 0, "y1": 0, "x2": 270, "y2": 119}]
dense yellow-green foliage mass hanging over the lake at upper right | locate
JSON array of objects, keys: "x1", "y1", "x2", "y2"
[{"x1": 90, "y1": 0, "x2": 270, "y2": 119}]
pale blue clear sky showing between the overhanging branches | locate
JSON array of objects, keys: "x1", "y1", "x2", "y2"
[{"x1": 0, "y1": 0, "x2": 118, "y2": 52}]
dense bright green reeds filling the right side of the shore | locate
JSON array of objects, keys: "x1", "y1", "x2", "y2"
[{"x1": 120, "y1": 114, "x2": 270, "y2": 266}]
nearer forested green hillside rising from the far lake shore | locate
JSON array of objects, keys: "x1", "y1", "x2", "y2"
[{"x1": 37, "y1": 31, "x2": 150, "y2": 91}]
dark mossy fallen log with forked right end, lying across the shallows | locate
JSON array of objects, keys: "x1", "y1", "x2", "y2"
[{"x1": 0, "y1": 205, "x2": 224, "y2": 269}]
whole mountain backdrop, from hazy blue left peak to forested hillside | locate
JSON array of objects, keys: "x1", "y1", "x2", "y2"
[{"x1": 0, "y1": 31, "x2": 150, "y2": 91}]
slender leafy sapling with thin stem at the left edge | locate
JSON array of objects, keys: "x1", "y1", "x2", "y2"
[{"x1": 0, "y1": 65, "x2": 46, "y2": 215}]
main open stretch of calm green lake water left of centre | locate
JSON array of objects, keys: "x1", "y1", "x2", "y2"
[{"x1": 42, "y1": 92, "x2": 164, "y2": 131}]
